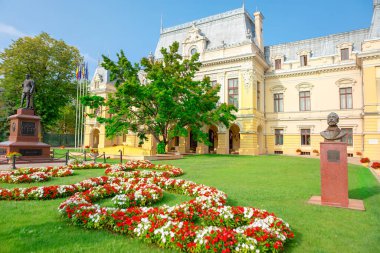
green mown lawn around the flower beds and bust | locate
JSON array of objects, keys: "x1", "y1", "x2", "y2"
[{"x1": 0, "y1": 155, "x2": 380, "y2": 252}]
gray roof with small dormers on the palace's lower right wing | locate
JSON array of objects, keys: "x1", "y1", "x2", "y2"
[{"x1": 264, "y1": 29, "x2": 369, "y2": 62}]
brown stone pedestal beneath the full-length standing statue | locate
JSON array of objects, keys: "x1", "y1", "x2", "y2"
[{"x1": 0, "y1": 108, "x2": 50, "y2": 160}]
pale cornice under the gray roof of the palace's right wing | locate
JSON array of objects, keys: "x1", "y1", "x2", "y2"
[{"x1": 264, "y1": 64, "x2": 360, "y2": 79}]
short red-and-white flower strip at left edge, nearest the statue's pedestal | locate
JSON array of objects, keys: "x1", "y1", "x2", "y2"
[{"x1": 0, "y1": 167, "x2": 74, "y2": 184}]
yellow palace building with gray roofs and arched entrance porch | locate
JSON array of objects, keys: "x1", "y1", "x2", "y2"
[{"x1": 84, "y1": 0, "x2": 380, "y2": 160}]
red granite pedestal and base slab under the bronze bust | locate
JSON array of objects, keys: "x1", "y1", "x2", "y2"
[{"x1": 308, "y1": 142, "x2": 365, "y2": 211}]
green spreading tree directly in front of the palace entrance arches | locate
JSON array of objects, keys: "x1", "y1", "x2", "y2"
[{"x1": 82, "y1": 42, "x2": 236, "y2": 149}]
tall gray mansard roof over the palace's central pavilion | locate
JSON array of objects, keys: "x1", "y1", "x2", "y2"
[{"x1": 154, "y1": 7, "x2": 255, "y2": 58}]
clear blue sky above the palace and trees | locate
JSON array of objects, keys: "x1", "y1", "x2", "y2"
[{"x1": 0, "y1": 0, "x2": 373, "y2": 75}]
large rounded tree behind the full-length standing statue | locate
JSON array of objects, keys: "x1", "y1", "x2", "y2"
[{"x1": 0, "y1": 33, "x2": 81, "y2": 138}]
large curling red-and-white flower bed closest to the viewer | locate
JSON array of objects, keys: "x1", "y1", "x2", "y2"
[{"x1": 59, "y1": 177, "x2": 293, "y2": 252}]
